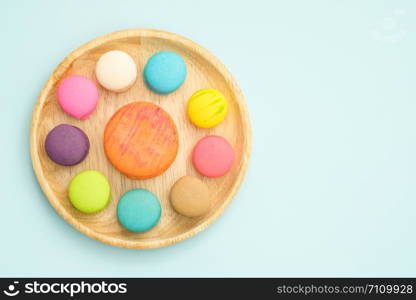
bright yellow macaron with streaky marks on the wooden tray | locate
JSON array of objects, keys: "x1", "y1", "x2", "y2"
[{"x1": 188, "y1": 89, "x2": 228, "y2": 128}]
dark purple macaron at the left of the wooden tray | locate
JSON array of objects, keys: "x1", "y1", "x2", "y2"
[{"x1": 45, "y1": 124, "x2": 90, "y2": 166}]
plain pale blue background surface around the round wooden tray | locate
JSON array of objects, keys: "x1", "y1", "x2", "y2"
[{"x1": 0, "y1": 0, "x2": 416, "y2": 276}]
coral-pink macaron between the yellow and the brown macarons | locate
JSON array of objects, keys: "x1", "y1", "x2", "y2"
[{"x1": 192, "y1": 135, "x2": 235, "y2": 177}]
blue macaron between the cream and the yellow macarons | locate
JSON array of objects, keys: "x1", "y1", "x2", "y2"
[{"x1": 143, "y1": 51, "x2": 186, "y2": 95}]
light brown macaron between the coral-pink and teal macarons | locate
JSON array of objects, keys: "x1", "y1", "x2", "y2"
[{"x1": 170, "y1": 176, "x2": 211, "y2": 217}]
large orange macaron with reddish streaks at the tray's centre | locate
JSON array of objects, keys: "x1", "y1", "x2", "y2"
[{"x1": 104, "y1": 102, "x2": 179, "y2": 179}]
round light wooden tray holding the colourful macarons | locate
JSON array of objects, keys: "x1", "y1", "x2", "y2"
[{"x1": 30, "y1": 29, "x2": 251, "y2": 249}]
